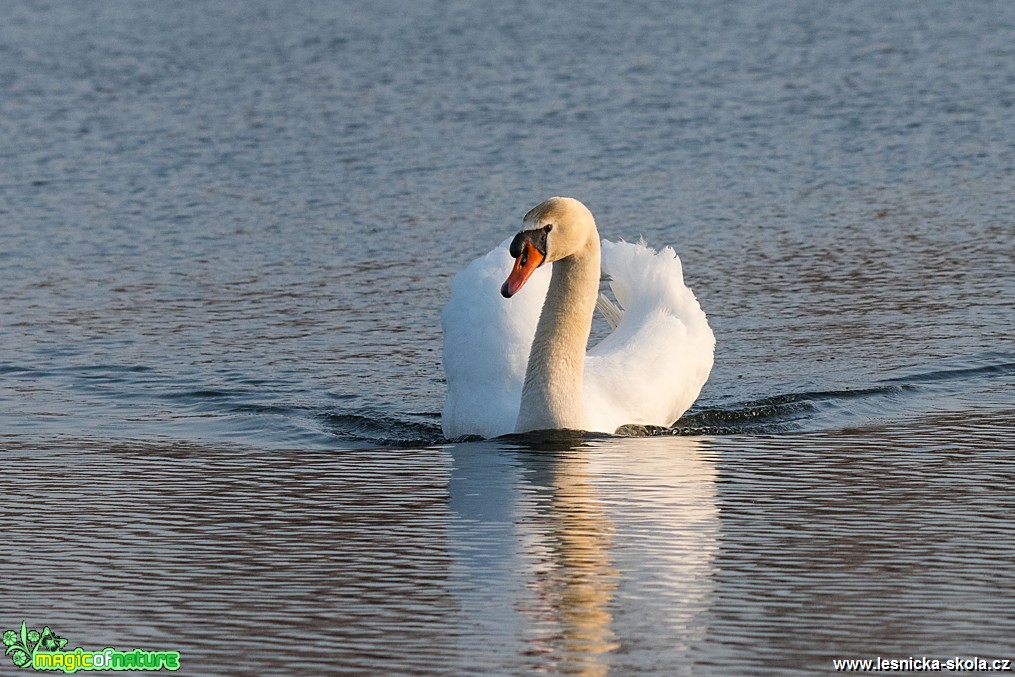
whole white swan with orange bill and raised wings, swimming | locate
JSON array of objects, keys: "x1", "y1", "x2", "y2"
[{"x1": 441, "y1": 197, "x2": 716, "y2": 439}]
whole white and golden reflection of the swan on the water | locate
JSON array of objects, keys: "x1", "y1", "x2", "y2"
[{"x1": 449, "y1": 437, "x2": 719, "y2": 675}]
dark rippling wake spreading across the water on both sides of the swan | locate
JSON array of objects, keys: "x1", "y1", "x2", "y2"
[{"x1": 0, "y1": 353, "x2": 1015, "y2": 449}]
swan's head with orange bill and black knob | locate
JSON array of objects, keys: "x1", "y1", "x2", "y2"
[{"x1": 500, "y1": 198, "x2": 599, "y2": 298}]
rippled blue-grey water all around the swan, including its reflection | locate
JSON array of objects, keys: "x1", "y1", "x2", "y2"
[{"x1": 0, "y1": 1, "x2": 1015, "y2": 675}]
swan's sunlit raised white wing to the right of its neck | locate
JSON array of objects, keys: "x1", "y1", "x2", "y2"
[{"x1": 585, "y1": 240, "x2": 716, "y2": 432}]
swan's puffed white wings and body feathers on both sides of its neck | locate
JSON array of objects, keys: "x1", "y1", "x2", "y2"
[{"x1": 441, "y1": 239, "x2": 716, "y2": 438}]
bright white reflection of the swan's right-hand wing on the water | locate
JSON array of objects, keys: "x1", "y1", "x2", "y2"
[{"x1": 587, "y1": 437, "x2": 721, "y2": 675}]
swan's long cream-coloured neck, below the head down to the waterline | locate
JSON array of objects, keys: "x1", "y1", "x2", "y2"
[{"x1": 515, "y1": 231, "x2": 600, "y2": 432}]
